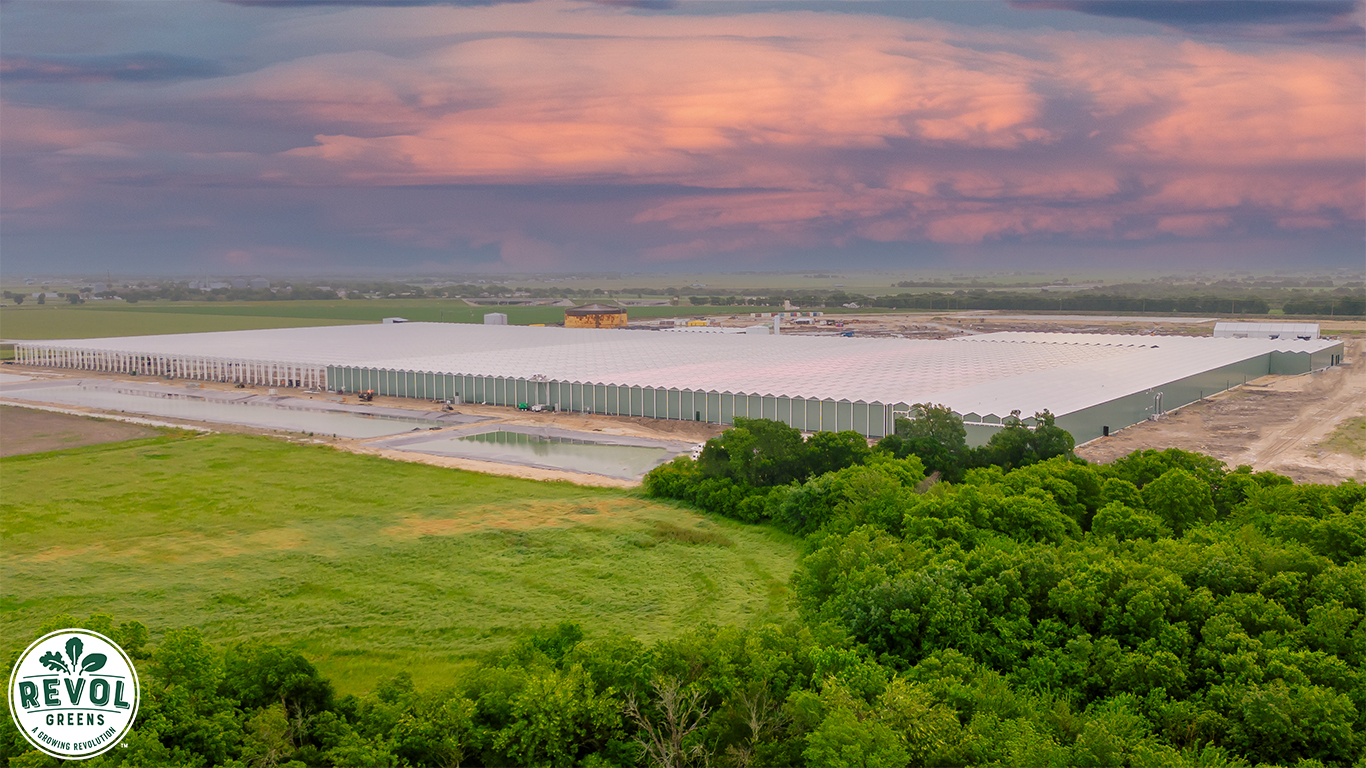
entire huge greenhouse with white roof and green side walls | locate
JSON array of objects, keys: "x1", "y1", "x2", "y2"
[{"x1": 15, "y1": 323, "x2": 1343, "y2": 443}]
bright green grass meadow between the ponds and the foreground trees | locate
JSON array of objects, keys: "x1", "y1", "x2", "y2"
[{"x1": 0, "y1": 435, "x2": 798, "y2": 691}]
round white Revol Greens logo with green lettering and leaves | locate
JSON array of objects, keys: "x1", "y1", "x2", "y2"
[{"x1": 10, "y1": 629, "x2": 138, "y2": 760}]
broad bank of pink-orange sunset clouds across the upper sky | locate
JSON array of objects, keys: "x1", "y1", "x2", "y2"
[{"x1": 4, "y1": 3, "x2": 1366, "y2": 259}]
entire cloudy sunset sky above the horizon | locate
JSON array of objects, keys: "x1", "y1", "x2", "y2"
[{"x1": 0, "y1": 0, "x2": 1366, "y2": 276}]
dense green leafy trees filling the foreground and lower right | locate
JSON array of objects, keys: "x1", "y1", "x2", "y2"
[{"x1": 0, "y1": 404, "x2": 1366, "y2": 768}]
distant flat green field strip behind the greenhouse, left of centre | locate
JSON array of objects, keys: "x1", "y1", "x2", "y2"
[{"x1": 0, "y1": 299, "x2": 885, "y2": 339}]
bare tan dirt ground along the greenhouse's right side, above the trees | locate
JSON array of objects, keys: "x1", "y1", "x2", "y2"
[{"x1": 1076, "y1": 338, "x2": 1366, "y2": 482}]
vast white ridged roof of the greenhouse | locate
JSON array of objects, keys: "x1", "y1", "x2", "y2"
[{"x1": 19, "y1": 323, "x2": 1339, "y2": 417}]
